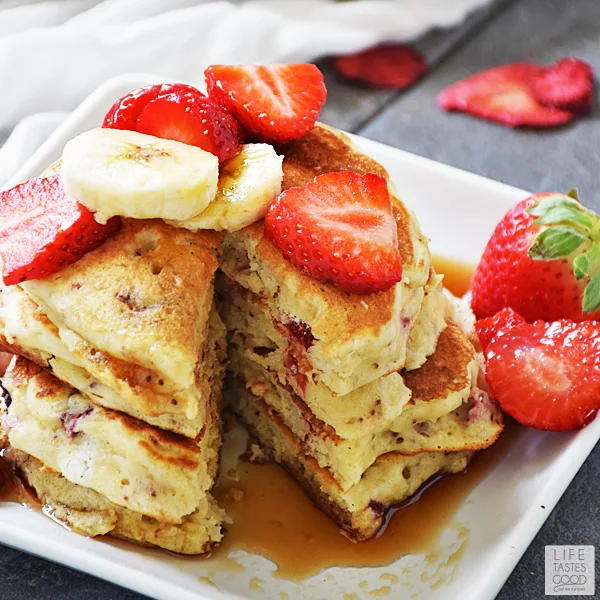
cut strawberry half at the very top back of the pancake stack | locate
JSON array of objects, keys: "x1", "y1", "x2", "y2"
[{"x1": 204, "y1": 64, "x2": 327, "y2": 144}]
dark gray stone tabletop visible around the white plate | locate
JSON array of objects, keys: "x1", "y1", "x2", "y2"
[{"x1": 0, "y1": 0, "x2": 600, "y2": 600}]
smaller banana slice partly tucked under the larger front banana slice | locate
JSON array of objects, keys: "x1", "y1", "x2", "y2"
[{"x1": 167, "y1": 144, "x2": 283, "y2": 231}]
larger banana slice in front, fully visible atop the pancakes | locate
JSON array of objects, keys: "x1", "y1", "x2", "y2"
[{"x1": 61, "y1": 129, "x2": 219, "y2": 223}]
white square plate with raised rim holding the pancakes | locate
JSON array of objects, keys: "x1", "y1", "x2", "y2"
[{"x1": 0, "y1": 75, "x2": 600, "y2": 600}]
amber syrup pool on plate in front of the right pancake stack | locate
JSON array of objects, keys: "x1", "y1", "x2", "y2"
[{"x1": 214, "y1": 426, "x2": 518, "y2": 580}]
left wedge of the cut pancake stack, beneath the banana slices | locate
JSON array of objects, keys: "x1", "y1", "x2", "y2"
[{"x1": 0, "y1": 220, "x2": 226, "y2": 554}]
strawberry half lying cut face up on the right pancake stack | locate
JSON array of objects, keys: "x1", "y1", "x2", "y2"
[{"x1": 265, "y1": 171, "x2": 402, "y2": 294}]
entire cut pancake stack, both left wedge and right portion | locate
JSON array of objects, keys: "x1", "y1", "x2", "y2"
[{"x1": 0, "y1": 125, "x2": 502, "y2": 554}]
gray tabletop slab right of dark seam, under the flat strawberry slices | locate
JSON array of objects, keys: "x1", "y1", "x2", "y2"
[{"x1": 359, "y1": 0, "x2": 600, "y2": 209}]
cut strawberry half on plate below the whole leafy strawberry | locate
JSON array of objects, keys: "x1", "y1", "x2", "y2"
[{"x1": 486, "y1": 320, "x2": 600, "y2": 431}]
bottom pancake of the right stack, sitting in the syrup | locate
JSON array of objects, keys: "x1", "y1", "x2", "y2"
[{"x1": 230, "y1": 382, "x2": 474, "y2": 541}]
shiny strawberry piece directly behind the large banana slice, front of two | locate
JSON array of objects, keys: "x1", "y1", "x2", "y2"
[{"x1": 136, "y1": 91, "x2": 243, "y2": 162}]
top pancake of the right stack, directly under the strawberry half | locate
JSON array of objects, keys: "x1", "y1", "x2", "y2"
[{"x1": 220, "y1": 124, "x2": 435, "y2": 394}]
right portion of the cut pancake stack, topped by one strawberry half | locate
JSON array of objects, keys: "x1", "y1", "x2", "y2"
[{"x1": 217, "y1": 125, "x2": 502, "y2": 540}]
